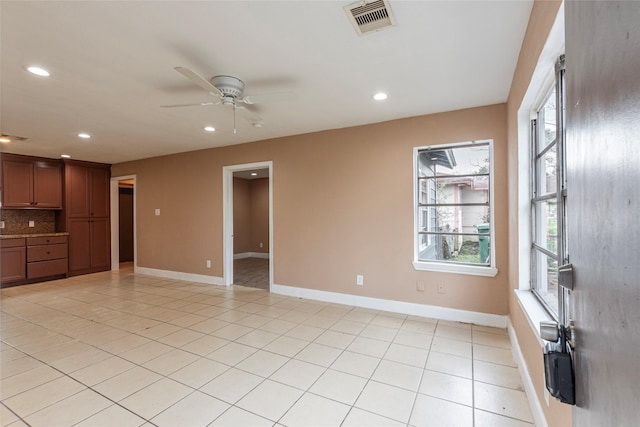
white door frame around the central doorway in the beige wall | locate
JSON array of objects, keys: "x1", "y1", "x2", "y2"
[{"x1": 222, "y1": 160, "x2": 274, "y2": 291}]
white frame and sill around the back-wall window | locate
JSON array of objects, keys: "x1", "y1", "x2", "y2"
[{"x1": 413, "y1": 139, "x2": 498, "y2": 277}]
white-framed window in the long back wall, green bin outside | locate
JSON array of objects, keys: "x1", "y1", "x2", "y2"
[{"x1": 414, "y1": 140, "x2": 497, "y2": 276}]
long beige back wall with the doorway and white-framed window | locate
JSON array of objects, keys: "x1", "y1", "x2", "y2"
[{"x1": 112, "y1": 104, "x2": 508, "y2": 315}]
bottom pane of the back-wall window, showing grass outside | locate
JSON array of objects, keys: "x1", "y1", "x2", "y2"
[{"x1": 419, "y1": 234, "x2": 491, "y2": 265}]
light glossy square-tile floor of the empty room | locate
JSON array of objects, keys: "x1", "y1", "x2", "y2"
[{"x1": 0, "y1": 269, "x2": 533, "y2": 427}]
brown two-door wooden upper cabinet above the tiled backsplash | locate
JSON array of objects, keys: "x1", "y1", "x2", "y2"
[{"x1": 2, "y1": 154, "x2": 62, "y2": 209}]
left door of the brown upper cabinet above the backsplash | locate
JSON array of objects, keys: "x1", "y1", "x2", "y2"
[{"x1": 2, "y1": 160, "x2": 33, "y2": 208}]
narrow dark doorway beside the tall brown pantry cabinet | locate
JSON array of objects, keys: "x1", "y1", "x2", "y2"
[{"x1": 111, "y1": 175, "x2": 136, "y2": 272}]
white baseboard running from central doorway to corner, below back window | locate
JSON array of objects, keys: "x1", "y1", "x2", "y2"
[{"x1": 271, "y1": 283, "x2": 508, "y2": 328}]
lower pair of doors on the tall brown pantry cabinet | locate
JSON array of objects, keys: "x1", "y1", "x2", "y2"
[{"x1": 67, "y1": 218, "x2": 111, "y2": 275}]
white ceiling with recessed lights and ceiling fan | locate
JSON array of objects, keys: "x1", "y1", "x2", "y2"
[{"x1": 0, "y1": 0, "x2": 533, "y2": 163}]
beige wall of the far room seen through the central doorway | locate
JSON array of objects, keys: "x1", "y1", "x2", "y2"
[{"x1": 233, "y1": 178, "x2": 269, "y2": 254}]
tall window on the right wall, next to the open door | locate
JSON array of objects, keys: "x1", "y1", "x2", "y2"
[{"x1": 531, "y1": 57, "x2": 568, "y2": 320}]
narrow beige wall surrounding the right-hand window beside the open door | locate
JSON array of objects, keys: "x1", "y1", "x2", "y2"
[{"x1": 507, "y1": 0, "x2": 571, "y2": 427}]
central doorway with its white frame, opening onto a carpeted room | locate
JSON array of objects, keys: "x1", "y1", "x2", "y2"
[{"x1": 223, "y1": 162, "x2": 273, "y2": 290}]
